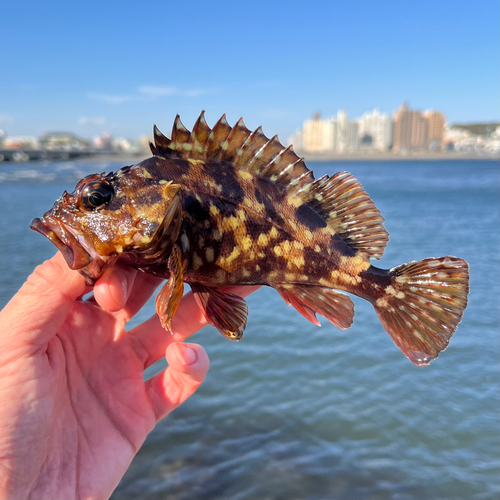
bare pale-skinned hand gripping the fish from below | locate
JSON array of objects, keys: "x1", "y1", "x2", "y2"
[{"x1": 0, "y1": 253, "x2": 257, "y2": 500}]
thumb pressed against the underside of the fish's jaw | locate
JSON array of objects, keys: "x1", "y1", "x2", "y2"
[{"x1": 0, "y1": 252, "x2": 87, "y2": 343}]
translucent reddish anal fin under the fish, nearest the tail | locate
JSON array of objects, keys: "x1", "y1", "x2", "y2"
[{"x1": 273, "y1": 284, "x2": 354, "y2": 330}]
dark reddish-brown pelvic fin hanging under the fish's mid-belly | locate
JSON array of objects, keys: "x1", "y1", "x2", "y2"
[{"x1": 190, "y1": 283, "x2": 248, "y2": 340}]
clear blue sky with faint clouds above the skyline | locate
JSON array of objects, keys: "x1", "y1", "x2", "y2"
[{"x1": 0, "y1": 0, "x2": 499, "y2": 141}]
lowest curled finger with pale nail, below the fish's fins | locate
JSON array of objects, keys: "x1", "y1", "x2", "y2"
[{"x1": 146, "y1": 342, "x2": 210, "y2": 422}]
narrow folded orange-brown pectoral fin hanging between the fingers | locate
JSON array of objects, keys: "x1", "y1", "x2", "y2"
[{"x1": 155, "y1": 245, "x2": 186, "y2": 332}]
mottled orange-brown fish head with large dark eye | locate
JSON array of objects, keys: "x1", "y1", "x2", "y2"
[{"x1": 31, "y1": 165, "x2": 180, "y2": 285}]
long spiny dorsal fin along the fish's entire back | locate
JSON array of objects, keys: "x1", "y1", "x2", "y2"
[{"x1": 151, "y1": 112, "x2": 389, "y2": 259}]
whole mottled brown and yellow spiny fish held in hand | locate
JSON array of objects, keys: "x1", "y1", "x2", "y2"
[{"x1": 31, "y1": 112, "x2": 469, "y2": 366}]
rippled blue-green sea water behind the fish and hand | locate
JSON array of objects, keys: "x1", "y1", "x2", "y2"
[{"x1": 0, "y1": 160, "x2": 500, "y2": 500}]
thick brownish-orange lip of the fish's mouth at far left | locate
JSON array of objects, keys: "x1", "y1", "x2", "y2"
[{"x1": 30, "y1": 216, "x2": 93, "y2": 271}]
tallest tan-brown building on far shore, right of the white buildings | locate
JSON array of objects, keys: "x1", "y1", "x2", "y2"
[{"x1": 392, "y1": 103, "x2": 429, "y2": 152}]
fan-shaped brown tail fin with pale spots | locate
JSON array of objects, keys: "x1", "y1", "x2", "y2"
[{"x1": 374, "y1": 257, "x2": 469, "y2": 366}]
